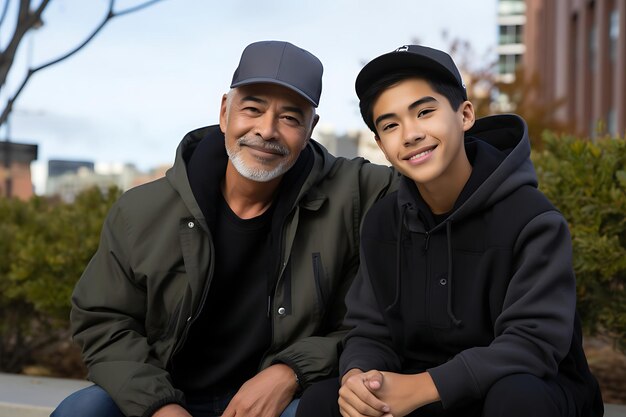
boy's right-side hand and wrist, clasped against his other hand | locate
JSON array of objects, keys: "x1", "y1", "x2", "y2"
[{"x1": 366, "y1": 372, "x2": 440, "y2": 417}]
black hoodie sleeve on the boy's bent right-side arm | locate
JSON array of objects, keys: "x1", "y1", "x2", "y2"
[{"x1": 428, "y1": 211, "x2": 576, "y2": 408}]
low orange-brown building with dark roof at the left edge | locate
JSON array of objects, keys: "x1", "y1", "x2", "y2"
[{"x1": 0, "y1": 141, "x2": 37, "y2": 200}]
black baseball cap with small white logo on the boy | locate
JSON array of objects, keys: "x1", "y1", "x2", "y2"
[{"x1": 355, "y1": 45, "x2": 467, "y2": 100}]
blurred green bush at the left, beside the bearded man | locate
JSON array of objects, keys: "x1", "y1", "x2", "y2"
[{"x1": 0, "y1": 189, "x2": 119, "y2": 372}]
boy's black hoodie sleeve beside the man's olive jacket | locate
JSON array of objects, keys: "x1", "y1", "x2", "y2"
[{"x1": 339, "y1": 254, "x2": 401, "y2": 376}]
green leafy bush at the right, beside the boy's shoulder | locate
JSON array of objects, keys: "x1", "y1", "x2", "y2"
[{"x1": 533, "y1": 132, "x2": 626, "y2": 349}]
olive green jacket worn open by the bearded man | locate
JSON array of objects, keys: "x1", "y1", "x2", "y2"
[{"x1": 71, "y1": 126, "x2": 396, "y2": 416}]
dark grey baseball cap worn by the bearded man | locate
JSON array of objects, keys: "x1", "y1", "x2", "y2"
[{"x1": 230, "y1": 41, "x2": 324, "y2": 107}]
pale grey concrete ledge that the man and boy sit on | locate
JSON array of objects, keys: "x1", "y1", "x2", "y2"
[{"x1": 0, "y1": 373, "x2": 626, "y2": 417}]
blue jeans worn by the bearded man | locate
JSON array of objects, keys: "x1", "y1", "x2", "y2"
[{"x1": 50, "y1": 385, "x2": 300, "y2": 417}]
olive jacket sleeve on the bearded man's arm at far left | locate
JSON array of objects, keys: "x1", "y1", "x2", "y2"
[{"x1": 71, "y1": 206, "x2": 184, "y2": 416}]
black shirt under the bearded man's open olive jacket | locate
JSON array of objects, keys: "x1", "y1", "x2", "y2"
[{"x1": 171, "y1": 134, "x2": 314, "y2": 402}]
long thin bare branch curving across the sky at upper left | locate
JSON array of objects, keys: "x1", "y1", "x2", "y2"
[{"x1": 0, "y1": 0, "x2": 162, "y2": 126}]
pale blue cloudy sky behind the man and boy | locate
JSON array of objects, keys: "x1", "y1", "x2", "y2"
[{"x1": 0, "y1": 0, "x2": 497, "y2": 192}]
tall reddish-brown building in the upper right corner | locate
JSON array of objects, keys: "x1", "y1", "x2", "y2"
[{"x1": 524, "y1": 0, "x2": 626, "y2": 137}]
